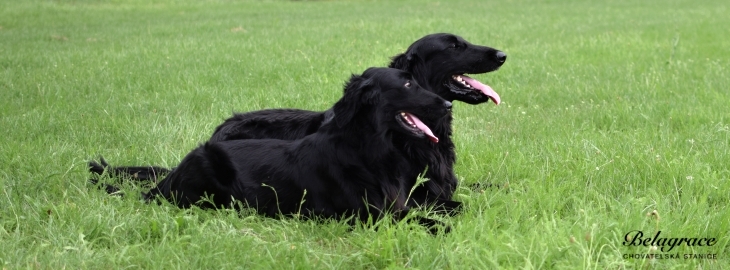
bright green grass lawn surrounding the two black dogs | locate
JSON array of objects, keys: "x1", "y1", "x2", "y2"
[{"x1": 0, "y1": 0, "x2": 730, "y2": 269}]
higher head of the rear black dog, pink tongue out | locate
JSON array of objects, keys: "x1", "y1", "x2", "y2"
[{"x1": 389, "y1": 33, "x2": 507, "y2": 104}]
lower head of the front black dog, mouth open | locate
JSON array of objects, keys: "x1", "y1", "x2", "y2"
[{"x1": 333, "y1": 68, "x2": 451, "y2": 142}]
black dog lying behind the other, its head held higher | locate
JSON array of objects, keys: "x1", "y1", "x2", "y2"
[{"x1": 90, "y1": 33, "x2": 507, "y2": 211}]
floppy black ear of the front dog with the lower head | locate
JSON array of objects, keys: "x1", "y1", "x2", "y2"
[{"x1": 333, "y1": 75, "x2": 379, "y2": 127}]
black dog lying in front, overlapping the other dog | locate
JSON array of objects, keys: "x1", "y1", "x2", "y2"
[{"x1": 145, "y1": 68, "x2": 451, "y2": 228}]
